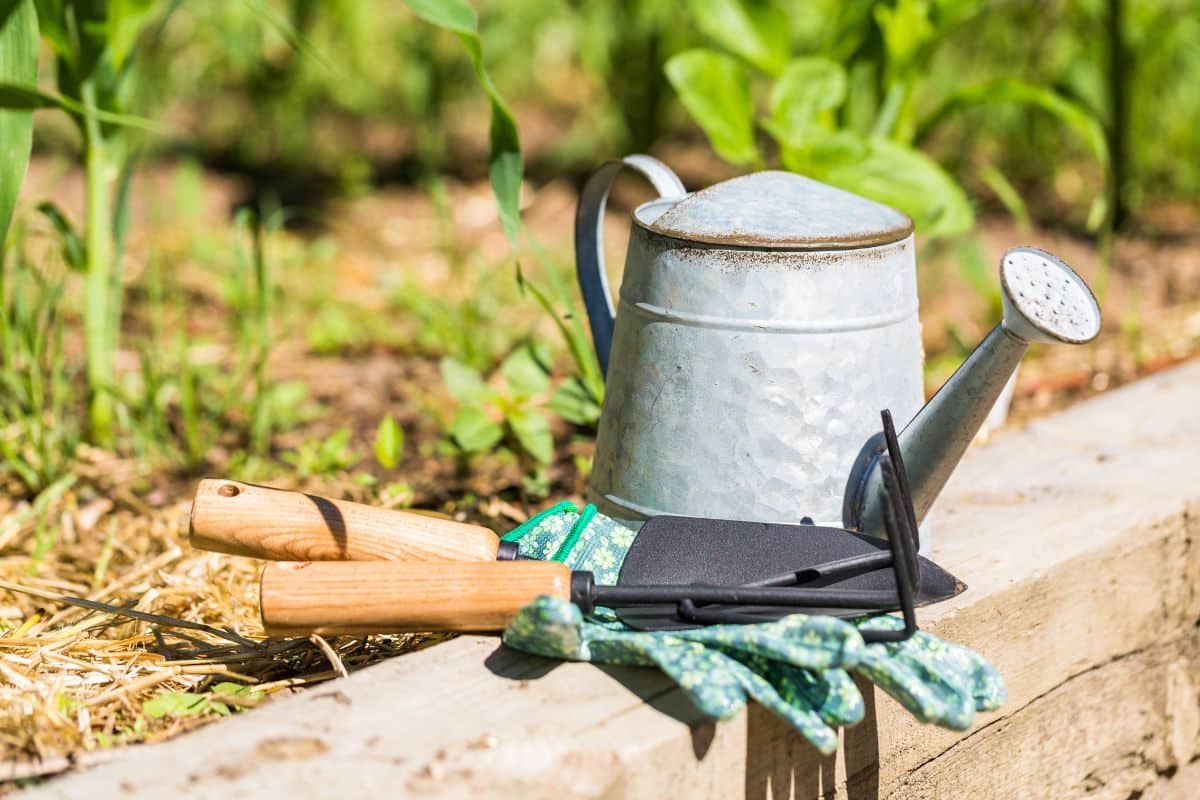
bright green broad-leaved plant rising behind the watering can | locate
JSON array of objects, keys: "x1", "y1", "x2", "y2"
[{"x1": 665, "y1": 0, "x2": 1108, "y2": 236}]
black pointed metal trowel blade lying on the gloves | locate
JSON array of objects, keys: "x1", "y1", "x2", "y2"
[{"x1": 616, "y1": 516, "x2": 966, "y2": 630}]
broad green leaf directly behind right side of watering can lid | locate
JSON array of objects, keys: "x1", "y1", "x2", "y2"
[{"x1": 784, "y1": 131, "x2": 974, "y2": 236}]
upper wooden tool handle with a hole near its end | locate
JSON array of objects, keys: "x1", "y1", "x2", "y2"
[{"x1": 190, "y1": 479, "x2": 500, "y2": 561}]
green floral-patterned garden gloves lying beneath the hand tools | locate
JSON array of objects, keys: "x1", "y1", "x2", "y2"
[{"x1": 504, "y1": 504, "x2": 1004, "y2": 752}]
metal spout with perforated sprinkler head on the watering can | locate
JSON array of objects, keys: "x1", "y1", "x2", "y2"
[{"x1": 842, "y1": 247, "x2": 1100, "y2": 537}]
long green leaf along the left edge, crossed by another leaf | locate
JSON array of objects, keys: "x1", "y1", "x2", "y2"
[{"x1": 0, "y1": 0, "x2": 37, "y2": 247}]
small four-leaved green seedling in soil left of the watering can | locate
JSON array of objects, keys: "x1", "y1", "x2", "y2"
[{"x1": 442, "y1": 344, "x2": 554, "y2": 473}]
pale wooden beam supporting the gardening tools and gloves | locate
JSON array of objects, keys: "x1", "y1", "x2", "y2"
[{"x1": 21, "y1": 363, "x2": 1200, "y2": 800}]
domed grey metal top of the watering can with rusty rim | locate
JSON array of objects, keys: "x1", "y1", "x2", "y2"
[{"x1": 648, "y1": 170, "x2": 912, "y2": 249}]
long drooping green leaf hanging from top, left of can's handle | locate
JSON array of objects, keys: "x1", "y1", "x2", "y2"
[{"x1": 404, "y1": 0, "x2": 524, "y2": 249}]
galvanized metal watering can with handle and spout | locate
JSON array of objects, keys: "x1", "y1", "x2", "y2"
[{"x1": 575, "y1": 156, "x2": 1100, "y2": 541}]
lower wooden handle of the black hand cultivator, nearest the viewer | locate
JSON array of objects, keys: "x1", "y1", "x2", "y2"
[{"x1": 259, "y1": 561, "x2": 571, "y2": 636}]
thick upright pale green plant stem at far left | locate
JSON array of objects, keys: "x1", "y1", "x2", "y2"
[{"x1": 79, "y1": 79, "x2": 116, "y2": 445}]
